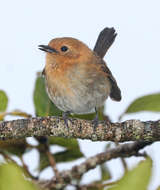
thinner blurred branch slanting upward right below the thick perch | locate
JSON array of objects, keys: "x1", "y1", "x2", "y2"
[{"x1": 40, "y1": 141, "x2": 150, "y2": 189}]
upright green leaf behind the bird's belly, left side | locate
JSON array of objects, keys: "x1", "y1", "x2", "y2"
[{"x1": 33, "y1": 76, "x2": 62, "y2": 116}]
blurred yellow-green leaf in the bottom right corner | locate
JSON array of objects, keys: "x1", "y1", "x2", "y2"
[{"x1": 108, "y1": 158, "x2": 152, "y2": 190}]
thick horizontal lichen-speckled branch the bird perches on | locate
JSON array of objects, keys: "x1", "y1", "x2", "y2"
[{"x1": 0, "y1": 116, "x2": 160, "y2": 142}]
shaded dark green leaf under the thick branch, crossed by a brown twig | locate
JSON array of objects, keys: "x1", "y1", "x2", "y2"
[{"x1": 39, "y1": 137, "x2": 84, "y2": 171}]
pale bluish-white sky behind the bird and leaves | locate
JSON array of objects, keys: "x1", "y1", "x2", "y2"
[{"x1": 0, "y1": 0, "x2": 160, "y2": 189}]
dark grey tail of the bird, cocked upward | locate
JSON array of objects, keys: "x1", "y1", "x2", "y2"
[{"x1": 93, "y1": 27, "x2": 117, "y2": 58}]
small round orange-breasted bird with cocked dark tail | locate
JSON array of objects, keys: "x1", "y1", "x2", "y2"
[{"x1": 39, "y1": 28, "x2": 121, "y2": 123}]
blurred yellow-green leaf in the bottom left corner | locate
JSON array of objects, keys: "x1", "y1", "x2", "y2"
[{"x1": 0, "y1": 164, "x2": 38, "y2": 190}]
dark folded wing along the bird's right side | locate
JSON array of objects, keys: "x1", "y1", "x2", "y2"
[{"x1": 100, "y1": 60, "x2": 122, "y2": 101}]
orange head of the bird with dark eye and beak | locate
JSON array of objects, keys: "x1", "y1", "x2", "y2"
[{"x1": 39, "y1": 37, "x2": 93, "y2": 64}]
